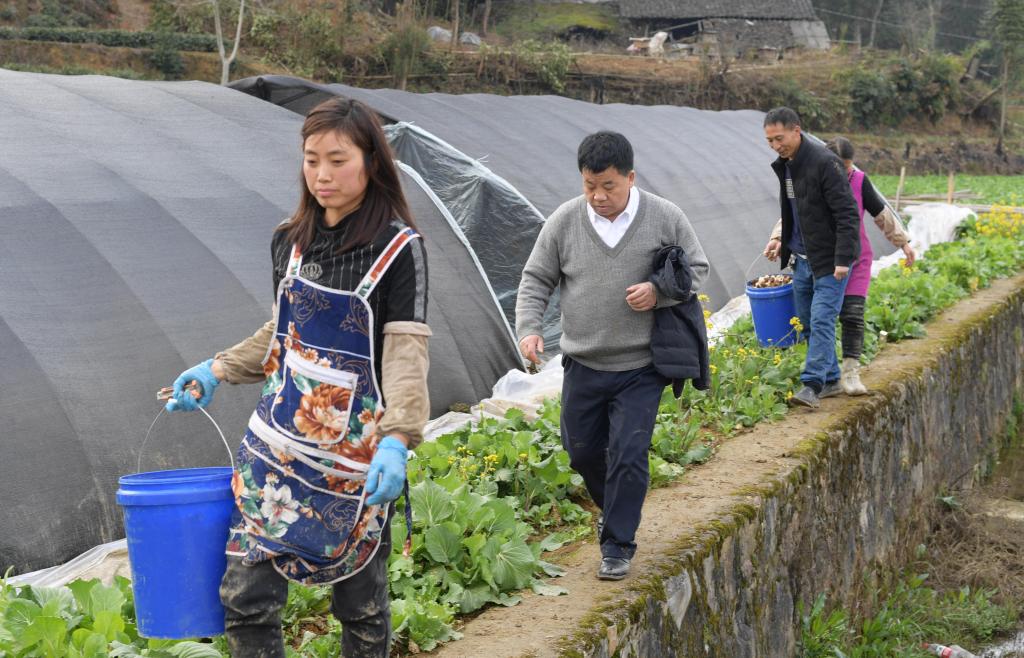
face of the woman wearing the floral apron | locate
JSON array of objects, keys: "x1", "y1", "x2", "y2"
[{"x1": 302, "y1": 131, "x2": 370, "y2": 226}]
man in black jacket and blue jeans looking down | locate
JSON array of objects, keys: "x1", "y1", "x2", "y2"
[{"x1": 764, "y1": 107, "x2": 860, "y2": 407}]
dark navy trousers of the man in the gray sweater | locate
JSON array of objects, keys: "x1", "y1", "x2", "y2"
[{"x1": 561, "y1": 356, "x2": 669, "y2": 558}]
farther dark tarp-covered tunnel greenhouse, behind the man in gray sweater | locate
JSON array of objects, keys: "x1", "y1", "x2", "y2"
[{"x1": 231, "y1": 76, "x2": 893, "y2": 345}]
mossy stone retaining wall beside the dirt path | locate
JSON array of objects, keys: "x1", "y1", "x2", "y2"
[{"x1": 560, "y1": 277, "x2": 1024, "y2": 658}]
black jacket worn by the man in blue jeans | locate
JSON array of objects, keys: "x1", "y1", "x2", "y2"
[{"x1": 771, "y1": 136, "x2": 860, "y2": 278}]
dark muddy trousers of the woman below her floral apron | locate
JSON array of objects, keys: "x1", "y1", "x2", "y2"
[{"x1": 220, "y1": 517, "x2": 391, "y2": 658}]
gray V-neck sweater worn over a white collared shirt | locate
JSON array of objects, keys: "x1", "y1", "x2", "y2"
[{"x1": 515, "y1": 190, "x2": 709, "y2": 371}]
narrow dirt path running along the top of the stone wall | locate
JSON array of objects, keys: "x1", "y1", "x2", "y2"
[{"x1": 431, "y1": 275, "x2": 1024, "y2": 658}]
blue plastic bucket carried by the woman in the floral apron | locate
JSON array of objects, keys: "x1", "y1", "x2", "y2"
[{"x1": 117, "y1": 467, "x2": 234, "y2": 640}]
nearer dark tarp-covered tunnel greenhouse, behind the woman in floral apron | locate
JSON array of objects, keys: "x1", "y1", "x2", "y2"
[{"x1": 0, "y1": 70, "x2": 519, "y2": 572}]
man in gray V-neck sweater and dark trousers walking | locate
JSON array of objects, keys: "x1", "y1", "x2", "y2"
[{"x1": 516, "y1": 132, "x2": 708, "y2": 580}]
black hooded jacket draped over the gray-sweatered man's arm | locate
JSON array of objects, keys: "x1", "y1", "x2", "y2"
[{"x1": 649, "y1": 247, "x2": 711, "y2": 397}]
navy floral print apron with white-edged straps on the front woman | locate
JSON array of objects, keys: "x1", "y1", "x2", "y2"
[{"x1": 226, "y1": 228, "x2": 420, "y2": 584}]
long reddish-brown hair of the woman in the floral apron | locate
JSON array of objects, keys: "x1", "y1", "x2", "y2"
[{"x1": 278, "y1": 98, "x2": 416, "y2": 252}]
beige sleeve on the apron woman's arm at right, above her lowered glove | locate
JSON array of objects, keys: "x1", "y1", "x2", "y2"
[{"x1": 380, "y1": 321, "x2": 432, "y2": 448}]
